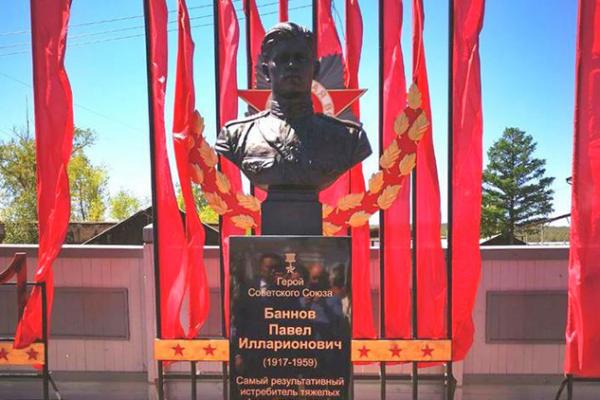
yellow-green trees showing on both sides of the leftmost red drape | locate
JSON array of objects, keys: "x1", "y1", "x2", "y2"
[{"x1": 0, "y1": 128, "x2": 107, "y2": 243}]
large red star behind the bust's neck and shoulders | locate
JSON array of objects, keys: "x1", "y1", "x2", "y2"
[{"x1": 238, "y1": 80, "x2": 367, "y2": 117}]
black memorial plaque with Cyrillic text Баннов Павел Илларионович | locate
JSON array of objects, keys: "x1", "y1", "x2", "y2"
[{"x1": 229, "y1": 236, "x2": 351, "y2": 400}]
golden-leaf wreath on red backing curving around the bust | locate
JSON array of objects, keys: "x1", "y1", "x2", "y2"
[{"x1": 188, "y1": 83, "x2": 429, "y2": 236}]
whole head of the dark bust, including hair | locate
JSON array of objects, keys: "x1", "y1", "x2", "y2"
[{"x1": 261, "y1": 22, "x2": 319, "y2": 99}]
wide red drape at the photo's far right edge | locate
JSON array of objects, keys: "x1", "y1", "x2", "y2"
[{"x1": 565, "y1": 0, "x2": 600, "y2": 378}]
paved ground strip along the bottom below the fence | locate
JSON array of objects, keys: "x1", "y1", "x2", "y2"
[{"x1": 0, "y1": 378, "x2": 600, "y2": 400}]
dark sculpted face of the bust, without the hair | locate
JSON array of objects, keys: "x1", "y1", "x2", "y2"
[{"x1": 262, "y1": 37, "x2": 318, "y2": 98}]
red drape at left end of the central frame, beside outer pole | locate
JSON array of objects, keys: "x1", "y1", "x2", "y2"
[{"x1": 146, "y1": 0, "x2": 187, "y2": 339}]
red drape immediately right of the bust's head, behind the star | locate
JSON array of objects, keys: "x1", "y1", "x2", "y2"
[{"x1": 316, "y1": 0, "x2": 350, "y2": 209}]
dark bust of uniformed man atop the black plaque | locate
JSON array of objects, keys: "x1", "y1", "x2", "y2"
[{"x1": 216, "y1": 22, "x2": 371, "y2": 234}]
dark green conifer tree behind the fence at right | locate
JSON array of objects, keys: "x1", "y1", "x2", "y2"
[{"x1": 481, "y1": 128, "x2": 554, "y2": 241}]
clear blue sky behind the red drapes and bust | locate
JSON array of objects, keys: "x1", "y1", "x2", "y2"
[{"x1": 0, "y1": 0, "x2": 577, "y2": 223}]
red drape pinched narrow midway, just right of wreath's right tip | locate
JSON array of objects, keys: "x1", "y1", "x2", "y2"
[{"x1": 413, "y1": 0, "x2": 446, "y2": 338}]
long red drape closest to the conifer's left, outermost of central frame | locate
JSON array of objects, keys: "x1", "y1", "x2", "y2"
[{"x1": 452, "y1": 0, "x2": 484, "y2": 360}]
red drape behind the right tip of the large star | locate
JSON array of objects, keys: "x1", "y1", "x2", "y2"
[{"x1": 346, "y1": 0, "x2": 376, "y2": 338}]
